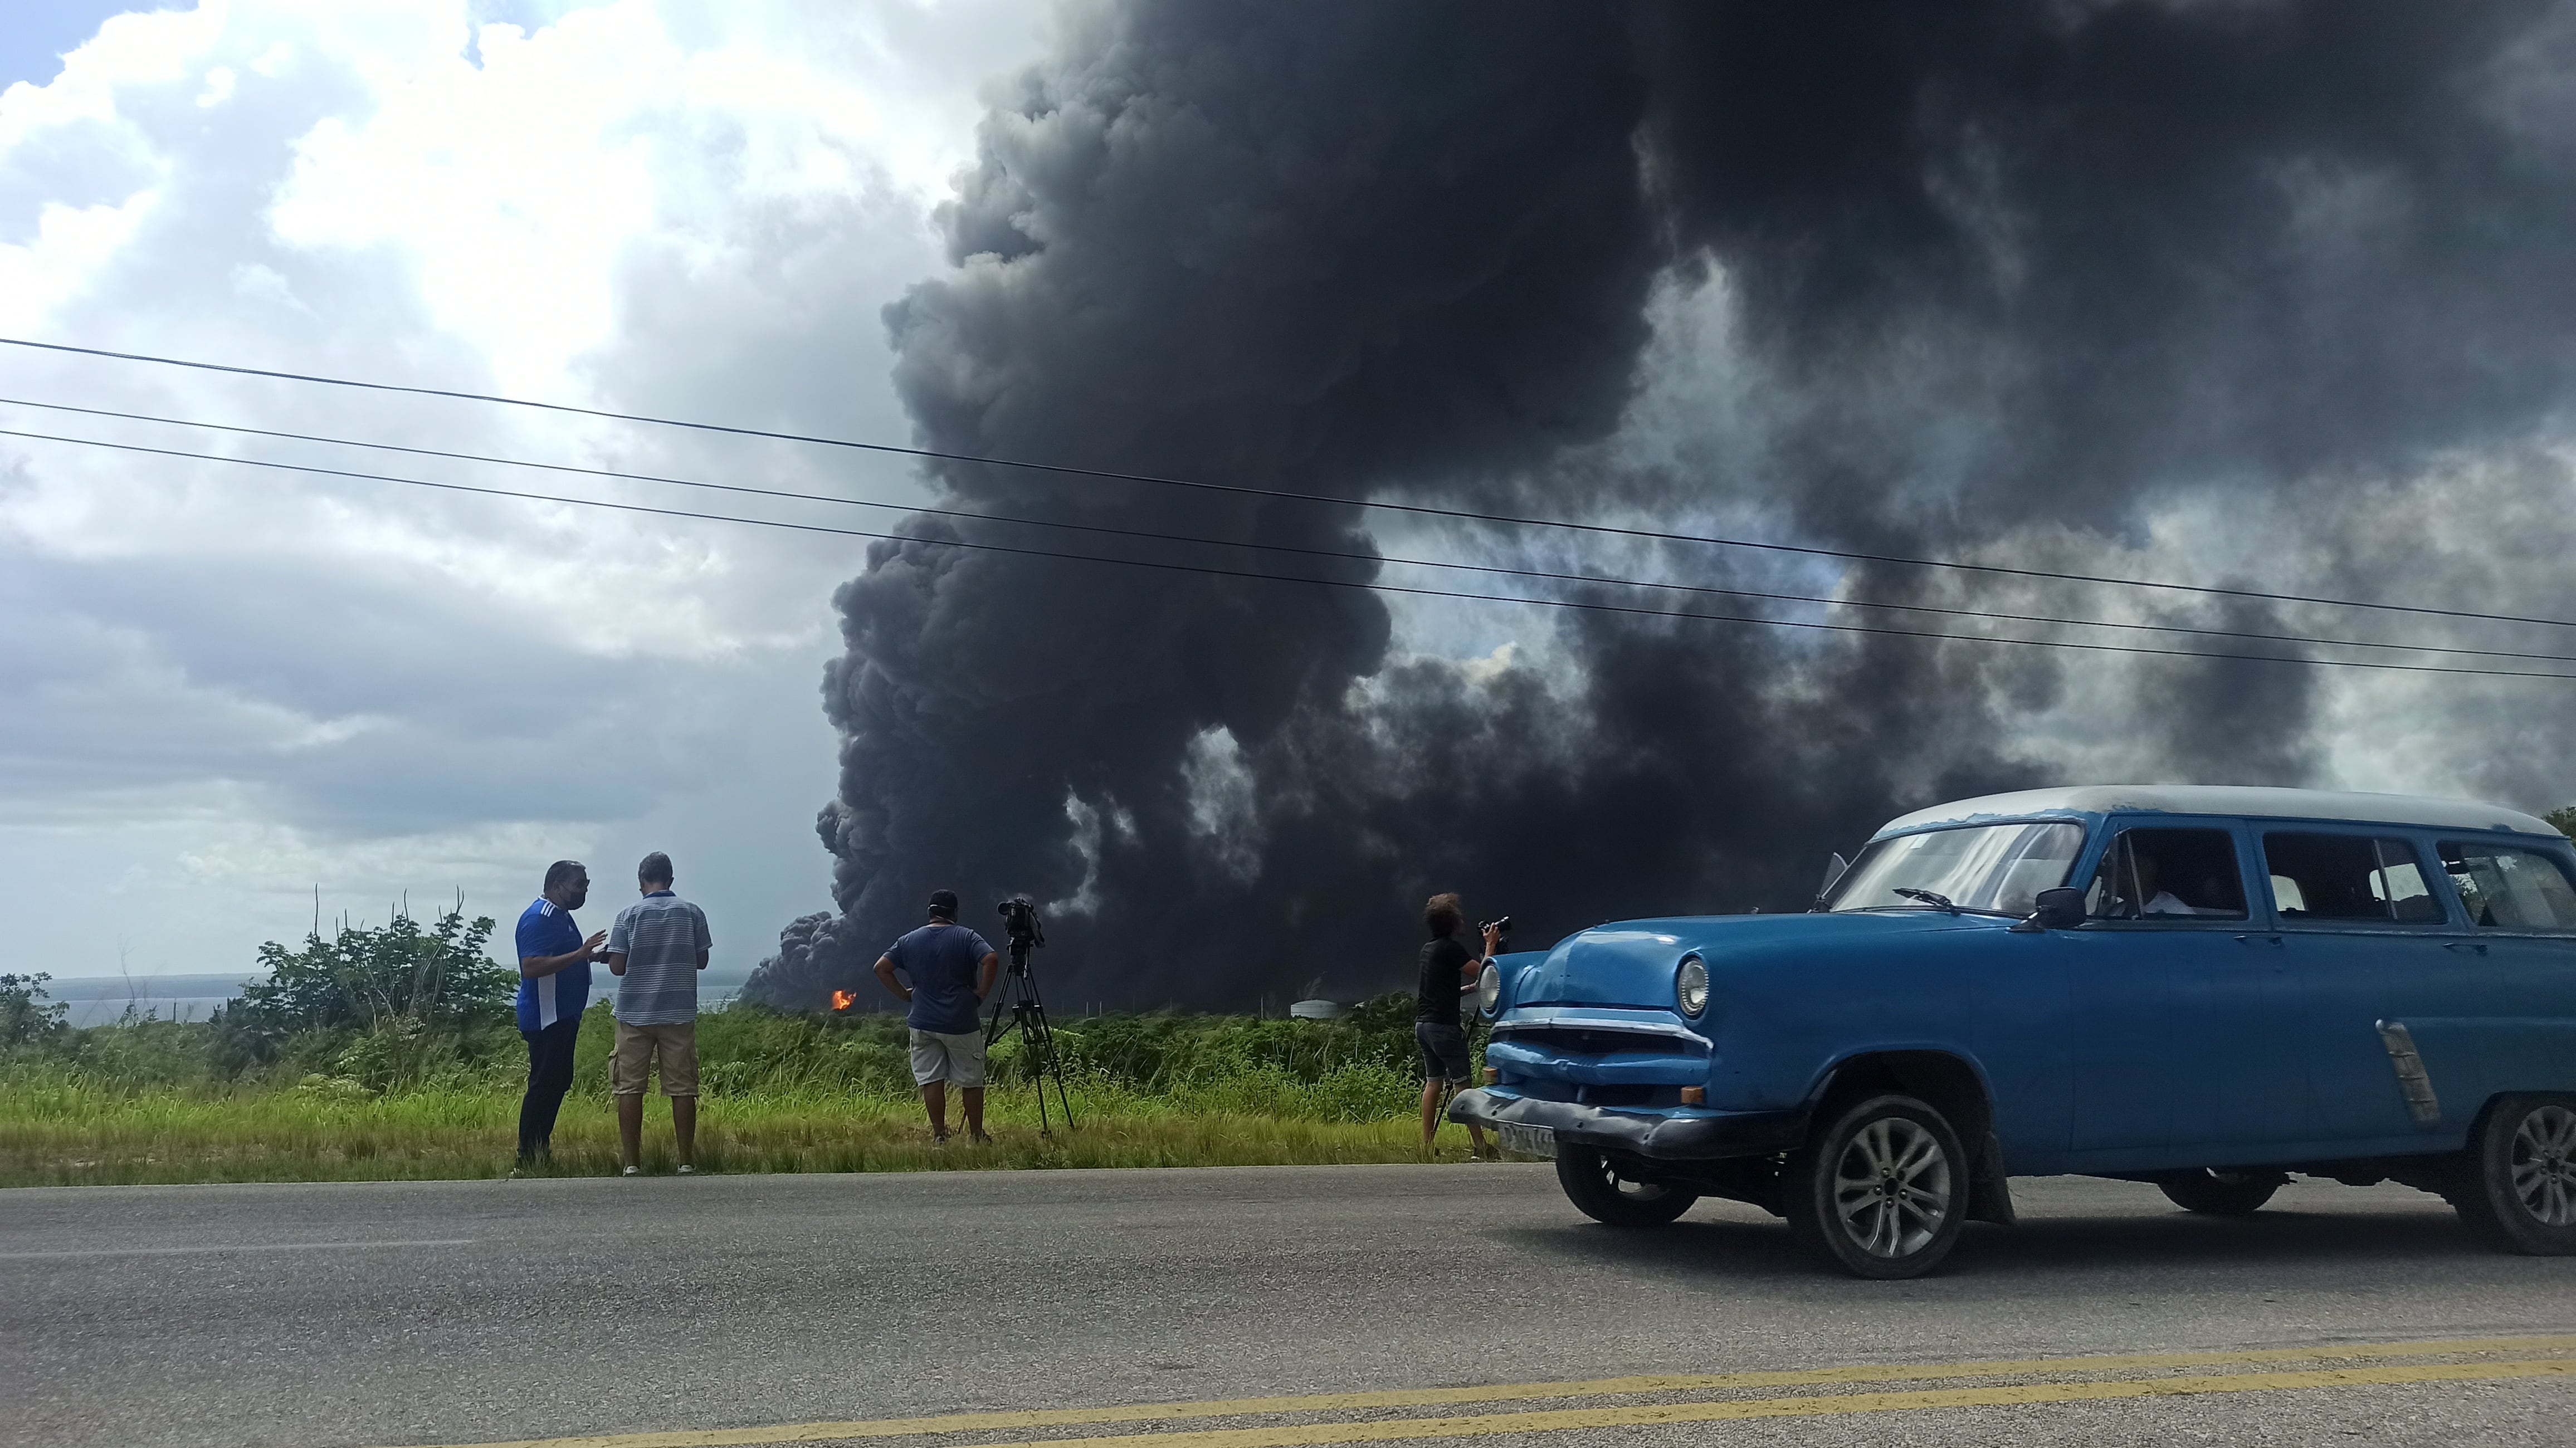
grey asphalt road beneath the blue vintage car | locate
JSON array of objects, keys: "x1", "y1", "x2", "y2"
[{"x1": 0, "y1": 1165, "x2": 2576, "y2": 1448}]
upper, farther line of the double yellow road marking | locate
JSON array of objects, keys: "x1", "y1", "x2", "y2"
[{"x1": 402, "y1": 1334, "x2": 2576, "y2": 1448}]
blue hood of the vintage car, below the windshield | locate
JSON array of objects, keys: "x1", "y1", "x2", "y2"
[{"x1": 1510, "y1": 909, "x2": 2009, "y2": 1010}]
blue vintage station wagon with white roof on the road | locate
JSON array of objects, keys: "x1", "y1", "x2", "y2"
[{"x1": 1450, "y1": 786, "x2": 2576, "y2": 1278}]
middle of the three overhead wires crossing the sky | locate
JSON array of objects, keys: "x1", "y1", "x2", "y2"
[{"x1": 0, "y1": 397, "x2": 2576, "y2": 665}]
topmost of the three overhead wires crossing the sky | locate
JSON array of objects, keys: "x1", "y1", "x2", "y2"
[{"x1": 0, "y1": 337, "x2": 2576, "y2": 629}]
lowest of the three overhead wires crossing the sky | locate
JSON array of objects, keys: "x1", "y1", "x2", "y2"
[{"x1": 0, "y1": 428, "x2": 2576, "y2": 680}]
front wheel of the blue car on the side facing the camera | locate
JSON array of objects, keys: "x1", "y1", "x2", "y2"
[{"x1": 1780, "y1": 1095, "x2": 1970, "y2": 1280}]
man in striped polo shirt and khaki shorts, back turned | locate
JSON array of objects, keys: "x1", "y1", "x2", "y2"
[{"x1": 608, "y1": 850, "x2": 709, "y2": 1177}]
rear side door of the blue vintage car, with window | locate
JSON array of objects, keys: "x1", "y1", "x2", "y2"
[{"x1": 2259, "y1": 822, "x2": 2476, "y2": 1149}]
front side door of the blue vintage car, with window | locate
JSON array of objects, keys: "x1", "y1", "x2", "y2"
[{"x1": 2068, "y1": 814, "x2": 2295, "y2": 1170}]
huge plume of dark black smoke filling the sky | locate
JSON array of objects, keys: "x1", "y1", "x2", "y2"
[{"x1": 736, "y1": 0, "x2": 2576, "y2": 1005}]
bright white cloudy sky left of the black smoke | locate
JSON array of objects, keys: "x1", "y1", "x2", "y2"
[{"x1": 0, "y1": 0, "x2": 1041, "y2": 976}]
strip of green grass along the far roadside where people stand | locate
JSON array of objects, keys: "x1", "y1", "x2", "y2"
[{"x1": 0, "y1": 989, "x2": 1466, "y2": 1185}]
